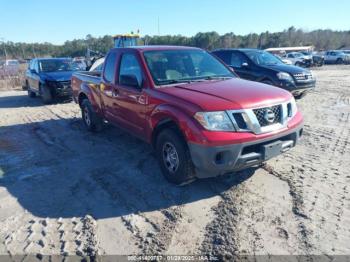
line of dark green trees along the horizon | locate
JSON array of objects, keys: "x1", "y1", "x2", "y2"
[{"x1": 0, "y1": 27, "x2": 350, "y2": 59}]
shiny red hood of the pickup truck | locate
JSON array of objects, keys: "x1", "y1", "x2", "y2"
[{"x1": 160, "y1": 78, "x2": 291, "y2": 111}]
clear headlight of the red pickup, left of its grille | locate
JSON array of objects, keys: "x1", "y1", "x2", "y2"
[{"x1": 194, "y1": 111, "x2": 235, "y2": 131}]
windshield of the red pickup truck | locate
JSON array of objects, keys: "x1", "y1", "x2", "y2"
[{"x1": 144, "y1": 50, "x2": 235, "y2": 85}]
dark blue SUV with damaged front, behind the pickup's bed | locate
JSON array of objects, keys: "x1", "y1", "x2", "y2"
[{"x1": 25, "y1": 58, "x2": 79, "y2": 104}]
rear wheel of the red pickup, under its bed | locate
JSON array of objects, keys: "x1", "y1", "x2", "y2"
[{"x1": 81, "y1": 99, "x2": 103, "y2": 132}]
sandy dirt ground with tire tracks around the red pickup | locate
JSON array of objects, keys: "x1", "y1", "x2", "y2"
[{"x1": 0, "y1": 66, "x2": 350, "y2": 259}]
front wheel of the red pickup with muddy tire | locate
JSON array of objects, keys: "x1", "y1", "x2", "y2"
[{"x1": 156, "y1": 129, "x2": 195, "y2": 185}]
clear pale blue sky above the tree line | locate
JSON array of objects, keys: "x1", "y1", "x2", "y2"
[{"x1": 0, "y1": 0, "x2": 350, "y2": 44}]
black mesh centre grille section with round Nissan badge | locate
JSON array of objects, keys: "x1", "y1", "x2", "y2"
[{"x1": 253, "y1": 105, "x2": 282, "y2": 127}]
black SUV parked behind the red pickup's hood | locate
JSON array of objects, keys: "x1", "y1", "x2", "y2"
[{"x1": 212, "y1": 49, "x2": 316, "y2": 98}]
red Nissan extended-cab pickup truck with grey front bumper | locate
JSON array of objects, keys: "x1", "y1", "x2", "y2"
[{"x1": 72, "y1": 46, "x2": 303, "y2": 184}]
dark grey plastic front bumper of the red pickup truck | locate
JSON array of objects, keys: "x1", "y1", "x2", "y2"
[{"x1": 189, "y1": 125, "x2": 303, "y2": 178}]
